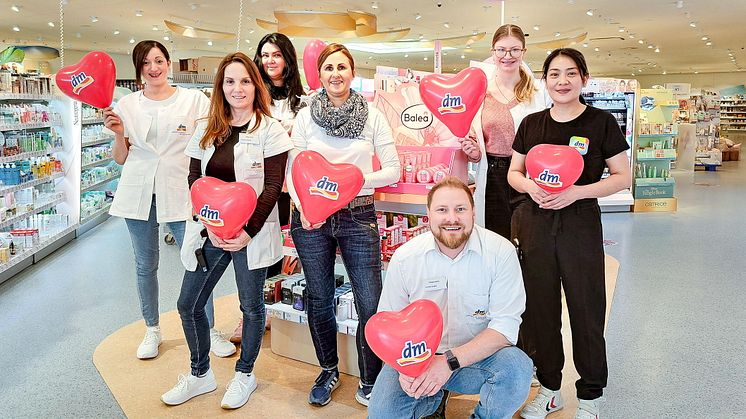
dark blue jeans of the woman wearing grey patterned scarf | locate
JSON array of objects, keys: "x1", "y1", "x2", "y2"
[{"x1": 291, "y1": 204, "x2": 383, "y2": 385}]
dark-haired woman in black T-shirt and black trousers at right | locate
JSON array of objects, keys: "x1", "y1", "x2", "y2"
[{"x1": 508, "y1": 48, "x2": 632, "y2": 419}]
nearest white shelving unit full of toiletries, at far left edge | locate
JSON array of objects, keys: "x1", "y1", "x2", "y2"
[{"x1": 0, "y1": 88, "x2": 80, "y2": 282}]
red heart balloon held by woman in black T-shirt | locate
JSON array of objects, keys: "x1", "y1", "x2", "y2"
[{"x1": 526, "y1": 144, "x2": 584, "y2": 193}]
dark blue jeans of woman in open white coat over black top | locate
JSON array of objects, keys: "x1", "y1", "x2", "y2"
[{"x1": 178, "y1": 240, "x2": 267, "y2": 376}]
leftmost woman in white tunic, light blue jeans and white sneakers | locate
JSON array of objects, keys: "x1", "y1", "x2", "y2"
[{"x1": 104, "y1": 41, "x2": 231, "y2": 359}]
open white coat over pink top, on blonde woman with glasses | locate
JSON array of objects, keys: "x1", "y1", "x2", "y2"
[{"x1": 472, "y1": 74, "x2": 552, "y2": 227}]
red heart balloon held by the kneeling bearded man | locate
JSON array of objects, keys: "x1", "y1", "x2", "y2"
[{"x1": 365, "y1": 300, "x2": 443, "y2": 377}]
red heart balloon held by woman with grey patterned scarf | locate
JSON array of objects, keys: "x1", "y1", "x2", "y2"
[{"x1": 292, "y1": 150, "x2": 365, "y2": 224}]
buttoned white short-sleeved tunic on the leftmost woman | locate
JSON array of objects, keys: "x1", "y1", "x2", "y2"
[{"x1": 109, "y1": 87, "x2": 210, "y2": 223}]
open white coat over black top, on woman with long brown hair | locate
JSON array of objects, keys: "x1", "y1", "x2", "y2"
[{"x1": 181, "y1": 117, "x2": 293, "y2": 271}]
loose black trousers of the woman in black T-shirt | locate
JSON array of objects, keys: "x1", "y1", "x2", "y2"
[{"x1": 512, "y1": 200, "x2": 608, "y2": 400}]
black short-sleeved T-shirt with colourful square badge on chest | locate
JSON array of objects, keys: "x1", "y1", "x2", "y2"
[{"x1": 513, "y1": 106, "x2": 629, "y2": 205}]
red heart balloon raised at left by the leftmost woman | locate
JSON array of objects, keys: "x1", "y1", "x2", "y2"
[{"x1": 54, "y1": 51, "x2": 117, "y2": 108}]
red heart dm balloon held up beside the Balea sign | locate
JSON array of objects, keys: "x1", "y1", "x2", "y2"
[{"x1": 420, "y1": 67, "x2": 487, "y2": 137}]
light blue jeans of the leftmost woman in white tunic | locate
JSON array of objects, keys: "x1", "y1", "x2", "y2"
[{"x1": 124, "y1": 196, "x2": 215, "y2": 328}]
